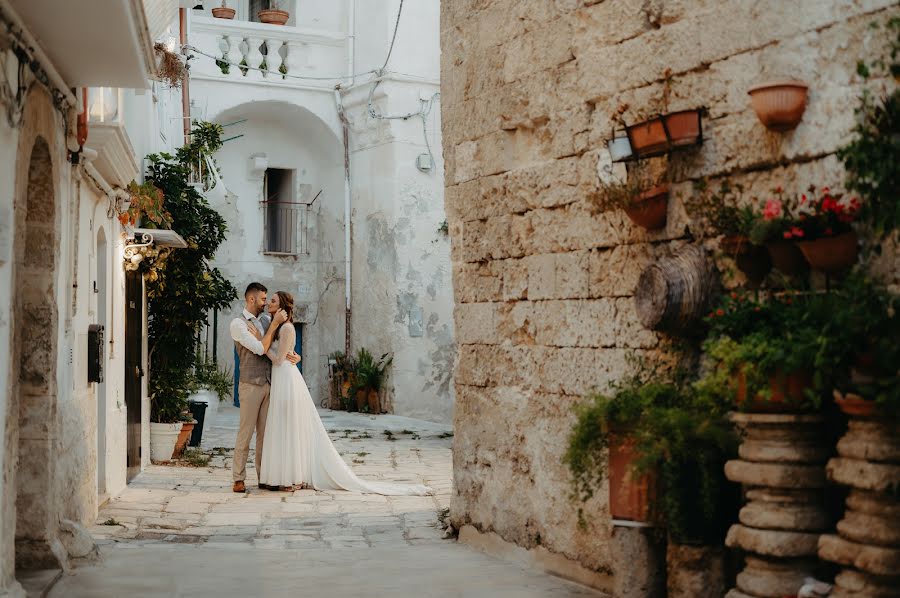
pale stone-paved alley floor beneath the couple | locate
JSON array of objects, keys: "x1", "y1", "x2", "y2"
[{"x1": 49, "y1": 406, "x2": 599, "y2": 598}]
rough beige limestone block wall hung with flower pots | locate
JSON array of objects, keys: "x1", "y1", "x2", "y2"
[{"x1": 441, "y1": 0, "x2": 897, "y2": 584}]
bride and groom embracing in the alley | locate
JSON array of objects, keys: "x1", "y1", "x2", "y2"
[{"x1": 230, "y1": 282, "x2": 431, "y2": 495}]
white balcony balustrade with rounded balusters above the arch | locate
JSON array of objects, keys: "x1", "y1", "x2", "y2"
[{"x1": 189, "y1": 16, "x2": 346, "y2": 89}]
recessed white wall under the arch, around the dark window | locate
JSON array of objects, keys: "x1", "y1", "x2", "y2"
[{"x1": 209, "y1": 102, "x2": 344, "y2": 403}]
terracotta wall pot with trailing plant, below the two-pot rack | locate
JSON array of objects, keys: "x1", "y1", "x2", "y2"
[{"x1": 593, "y1": 162, "x2": 669, "y2": 230}]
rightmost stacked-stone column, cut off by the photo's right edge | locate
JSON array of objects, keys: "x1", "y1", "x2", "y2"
[{"x1": 819, "y1": 416, "x2": 900, "y2": 598}]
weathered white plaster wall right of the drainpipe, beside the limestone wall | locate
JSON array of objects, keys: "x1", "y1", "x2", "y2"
[{"x1": 344, "y1": 1, "x2": 455, "y2": 421}]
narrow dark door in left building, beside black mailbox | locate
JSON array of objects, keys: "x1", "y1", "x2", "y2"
[{"x1": 125, "y1": 272, "x2": 144, "y2": 481}]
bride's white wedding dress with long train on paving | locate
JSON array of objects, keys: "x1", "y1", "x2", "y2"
[{"x1": 259, "y1": 324, "x2": 433, "y2": 496}]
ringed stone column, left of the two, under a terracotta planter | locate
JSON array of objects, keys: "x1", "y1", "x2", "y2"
[{"x1": 725, "y1": 413, "x2": 830, "y2": 598}]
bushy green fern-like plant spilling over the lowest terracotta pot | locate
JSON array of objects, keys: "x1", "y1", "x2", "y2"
[{"x1": 564, "y1": 373, "x2": 736, "y2": 544}]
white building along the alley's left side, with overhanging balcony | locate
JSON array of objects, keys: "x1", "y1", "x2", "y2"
[{"x1": 0, "y1": 0, "x2": 183, "y2": 596}]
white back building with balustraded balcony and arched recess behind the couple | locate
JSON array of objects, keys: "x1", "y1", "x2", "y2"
[{"x1": 188, "y1": 0, "x2": 455, "y2": 422}]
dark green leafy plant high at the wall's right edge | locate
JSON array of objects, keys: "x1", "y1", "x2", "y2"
[{"x1": 838, "y1": 17, "x2": 900, "y2": 238}]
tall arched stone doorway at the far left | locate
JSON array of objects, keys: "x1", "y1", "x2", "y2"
[{"x1": 10, "y1": 136, "x2": 65, "y2": 569}]
